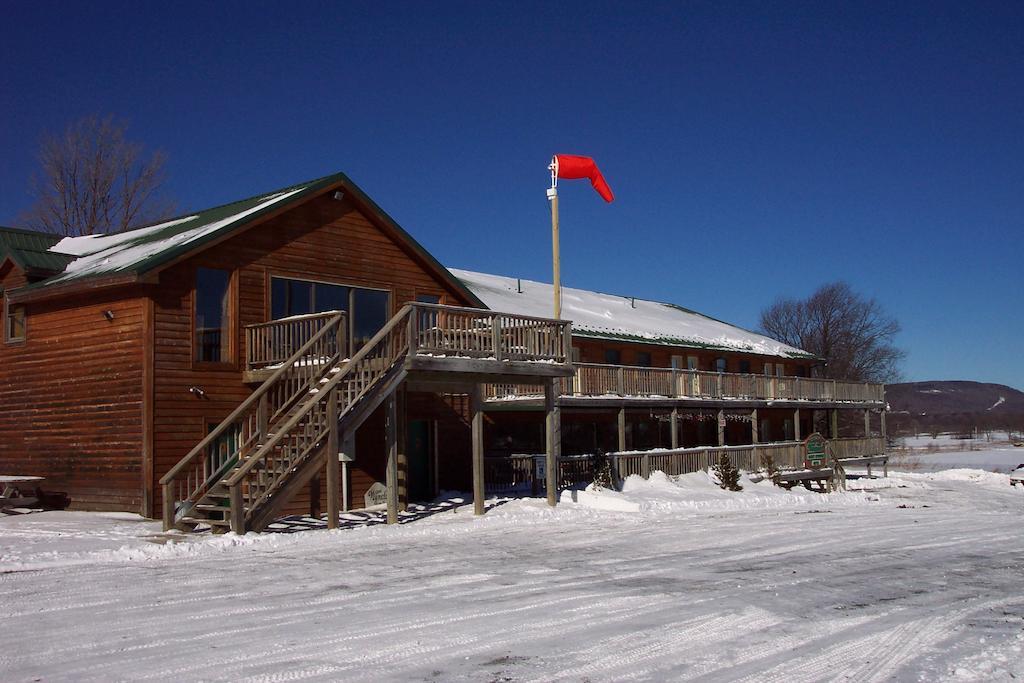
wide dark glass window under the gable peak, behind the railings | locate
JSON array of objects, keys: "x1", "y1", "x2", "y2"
[{"x1": 270, "y1": 278, "x2": 391, "y2": 352}]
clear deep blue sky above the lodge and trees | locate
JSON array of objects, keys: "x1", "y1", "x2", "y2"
[{"x1": 0, "y1": 0, "x2": 1024, "y2": 389}]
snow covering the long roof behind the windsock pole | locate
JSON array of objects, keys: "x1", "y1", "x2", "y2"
[{"x1": 449, "y1": 268, "x2": 813, "y2": 358}]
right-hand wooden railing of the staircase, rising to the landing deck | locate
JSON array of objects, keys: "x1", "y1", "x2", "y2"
[{"x1": 224, "y1": 304, "x2": 415, "y2": 533}]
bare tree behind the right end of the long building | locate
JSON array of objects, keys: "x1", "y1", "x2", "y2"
[{"x1": 761, "y1": 282, "x2": 906, "y2": 382}]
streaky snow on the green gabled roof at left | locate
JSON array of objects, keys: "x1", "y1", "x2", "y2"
[{"x1": 46, "y1": 185, "x2": 306, "y2": 285}]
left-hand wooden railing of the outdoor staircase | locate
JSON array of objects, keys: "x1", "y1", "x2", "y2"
[{"x1": 160, "y1": 311, "x2": 346, "y2": 529}]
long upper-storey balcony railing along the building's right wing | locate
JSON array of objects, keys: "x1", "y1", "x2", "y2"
[{"x1": 487, "y1": 362, "x2": 885, "y2": 403}]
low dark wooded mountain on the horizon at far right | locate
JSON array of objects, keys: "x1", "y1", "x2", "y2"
[{"x1": 886, "y1": 381, "x2": 1024, "y2": 417}]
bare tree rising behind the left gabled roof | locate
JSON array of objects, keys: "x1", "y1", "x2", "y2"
[{"x1": 23, "y1": 116, "x2": 174, "y2": 234}]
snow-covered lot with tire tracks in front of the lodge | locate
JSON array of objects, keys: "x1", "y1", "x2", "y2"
[{"x1": 0, "y1": 470, "x2": 1024, "y2": 682}]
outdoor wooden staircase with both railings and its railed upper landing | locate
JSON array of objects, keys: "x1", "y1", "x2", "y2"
[{"x1": 160, "y1": 303, "x2": 571, "y2": 533}]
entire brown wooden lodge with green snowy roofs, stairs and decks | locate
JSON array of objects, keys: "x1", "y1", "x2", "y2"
[{"x1": 0, "y1": 174, "x2": 885, "y2": 531}]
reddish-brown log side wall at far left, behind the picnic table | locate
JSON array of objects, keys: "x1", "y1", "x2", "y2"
[{"x1": 0, "y1": 290, "x2": 145, "y2": 511}]
